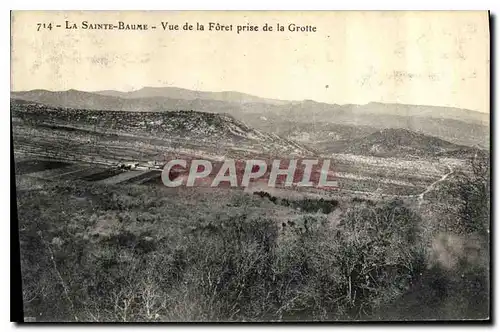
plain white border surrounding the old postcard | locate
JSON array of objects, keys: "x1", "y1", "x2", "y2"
[{"x1": 0, "y1": 0, "x2": 500, "y2": 331}]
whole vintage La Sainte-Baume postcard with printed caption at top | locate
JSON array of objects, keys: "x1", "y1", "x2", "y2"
[{"x1": 10, "y1": 11, "x2": 490, "y2": 322}]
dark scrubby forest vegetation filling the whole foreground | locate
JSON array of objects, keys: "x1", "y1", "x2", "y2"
[{"x1": 14, "y1": 154, "x2": 489, "y2": 321}]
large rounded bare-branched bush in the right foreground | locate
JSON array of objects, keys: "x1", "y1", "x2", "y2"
[{"x1": 337, "y1": 201, "x2": 425, "y2": 314}]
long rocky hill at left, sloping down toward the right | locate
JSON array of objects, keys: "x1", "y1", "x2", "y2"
[{"x1": 11, "y1": 100, "x2": 314, "y2": 156}]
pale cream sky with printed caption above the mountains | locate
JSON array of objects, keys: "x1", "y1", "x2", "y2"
[{"x1": 11, "y1": 11, "x2": 489, "y2": 112}]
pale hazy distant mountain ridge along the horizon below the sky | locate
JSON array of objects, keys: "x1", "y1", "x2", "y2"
[{"x1": 11, "y1": 88, "x2": 489, "y2": 148}]
